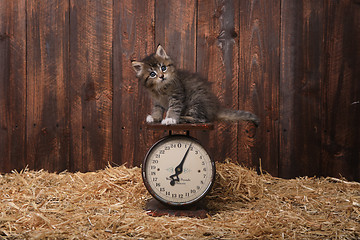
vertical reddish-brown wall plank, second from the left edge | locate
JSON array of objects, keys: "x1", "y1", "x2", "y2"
[{"x1": 27, "y1": 0, "x2": 69, "y2": 171}]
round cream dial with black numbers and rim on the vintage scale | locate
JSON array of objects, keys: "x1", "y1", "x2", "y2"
[{"x1": 142, "y1": 135, "x2": 215, "y2": 206}]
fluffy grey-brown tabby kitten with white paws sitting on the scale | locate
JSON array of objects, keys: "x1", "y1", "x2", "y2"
[{"x1": 132, "y1": 45, "x2": 260, "y2": 126}]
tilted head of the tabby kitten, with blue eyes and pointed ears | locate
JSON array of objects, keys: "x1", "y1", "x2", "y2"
[{"x1": 132, "y1": 45, "x2": 175, "y2": 90}]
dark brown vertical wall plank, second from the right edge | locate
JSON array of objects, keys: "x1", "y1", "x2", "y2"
[{"x1": 279, "y1": 1, "x2": 323, "y2": 177}]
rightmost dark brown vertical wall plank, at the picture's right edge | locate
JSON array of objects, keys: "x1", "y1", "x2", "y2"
[{"x1": 321, "y1": 0, "x2": 360, "y2": 180}]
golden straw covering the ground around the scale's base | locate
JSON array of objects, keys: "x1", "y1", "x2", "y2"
[{"x1": 0, "y1": 162, "x2": 360, "y2": 239}]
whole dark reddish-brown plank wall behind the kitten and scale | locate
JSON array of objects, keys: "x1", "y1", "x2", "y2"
[{"x1": 0, "y1": 0, "x2": 360, "y2": 180}]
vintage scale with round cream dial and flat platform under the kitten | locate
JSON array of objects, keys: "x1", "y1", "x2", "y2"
[{"x1": 142, "y1": 123, "x2": 215, "y2": 217}]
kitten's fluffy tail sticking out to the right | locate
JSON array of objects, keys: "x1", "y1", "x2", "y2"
[{"x1": 217, "y1": 109, "x2": 260, "y2": 126}]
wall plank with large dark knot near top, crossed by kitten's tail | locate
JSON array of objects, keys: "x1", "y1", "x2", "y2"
[{"x1": 196, "y1": 0, "x2": 242, "y2": 161}]
